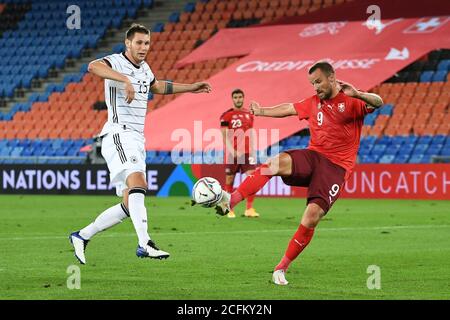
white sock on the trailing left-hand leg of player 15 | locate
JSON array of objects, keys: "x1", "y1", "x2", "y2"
[{"x1": 80, "y1": 203, "x2": 128, "y2": 240}]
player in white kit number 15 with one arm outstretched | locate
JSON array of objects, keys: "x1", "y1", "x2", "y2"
[{"x1": 69, "y1": 24, "x2": 211, "y2": 264}]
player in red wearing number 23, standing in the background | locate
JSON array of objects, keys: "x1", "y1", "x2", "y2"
[{"x1": 220, "y1": 89, "x2": 259, "y2": 218}]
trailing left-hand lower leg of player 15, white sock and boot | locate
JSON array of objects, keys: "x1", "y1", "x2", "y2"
[{"x1": 69, "y1": 203, "x2": 129, "y2": 264}]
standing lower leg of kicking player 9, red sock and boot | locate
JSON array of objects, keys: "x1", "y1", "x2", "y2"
[{"x1": 272, "y1": 202, "x2": 325, "y2": 285}]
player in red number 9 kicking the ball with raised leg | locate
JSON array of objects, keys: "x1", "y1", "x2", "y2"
[{"x1": 216, "y1": 61, "x2": 383, "y2": 285}]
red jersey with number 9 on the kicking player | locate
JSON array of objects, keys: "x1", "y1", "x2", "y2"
[{"x1": 294, "y1": 92, "x2": 373, "y2": 178}]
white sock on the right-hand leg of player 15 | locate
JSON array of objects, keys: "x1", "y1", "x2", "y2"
[{"x1": 128, "y1": 188, "x2": 150, "y2": 247}]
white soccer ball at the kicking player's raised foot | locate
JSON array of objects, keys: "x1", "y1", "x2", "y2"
[{"x1": 192, "y1": 177, "x2": 223, "y2": 208}]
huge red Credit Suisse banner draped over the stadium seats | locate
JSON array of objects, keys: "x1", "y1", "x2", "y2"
[{"x1": 145, "y1": 13, "x2": 450, "y2": 150}]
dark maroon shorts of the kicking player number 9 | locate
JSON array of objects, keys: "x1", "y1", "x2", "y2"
[{"x1": 281, "y1": 149, "x2": 346, "y2": 213}]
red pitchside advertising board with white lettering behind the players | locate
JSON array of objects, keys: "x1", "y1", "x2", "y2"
[{"x1": 198, "y1": 164, "x2": 450, "y2": 200}]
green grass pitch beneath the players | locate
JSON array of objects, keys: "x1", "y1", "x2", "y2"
[{"x1": 0, "y1": 195, "x2": 450, "y2": 300}]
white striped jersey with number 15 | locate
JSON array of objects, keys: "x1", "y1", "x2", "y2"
[{"x1": 100, "y1": 53, "x2": 155, "y2": 135}]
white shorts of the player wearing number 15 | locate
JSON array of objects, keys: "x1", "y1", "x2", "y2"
[{"x1": 102, "y1": 130, "x2": 147, "y2": 197}]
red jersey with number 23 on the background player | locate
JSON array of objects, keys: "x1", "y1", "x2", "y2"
[{"x1": 220, "y1": 108, "x2": 254, "y2": 153}]
